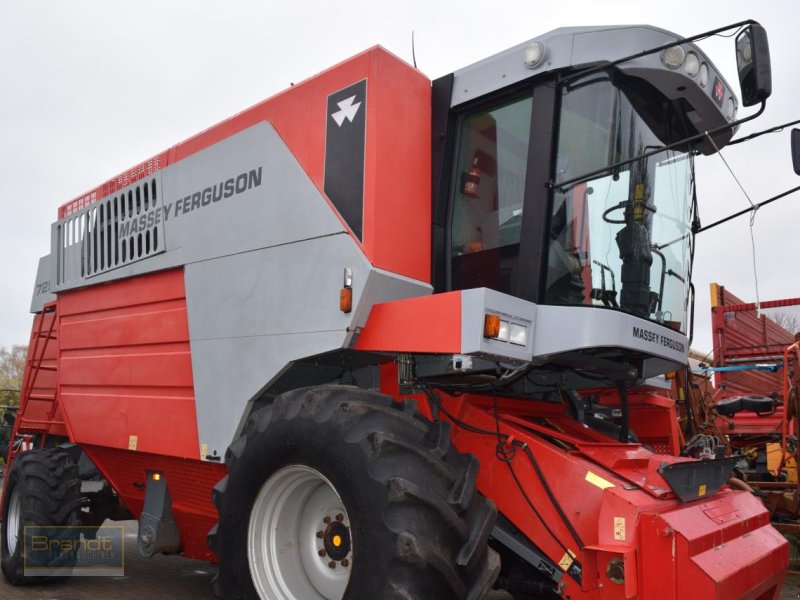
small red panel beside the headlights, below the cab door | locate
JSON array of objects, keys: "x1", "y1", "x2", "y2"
[{"x1": 356, "y1": 292, "x2": 461, "y2": 354}]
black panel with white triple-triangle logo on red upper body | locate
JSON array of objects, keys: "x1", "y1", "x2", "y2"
[{"x1": 323, "y1": 79, "x2": 369, "y2": 239}]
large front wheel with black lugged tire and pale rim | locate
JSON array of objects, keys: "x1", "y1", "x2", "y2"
[{"x1": 209, "y1": 386, "x2": 500, "y2": 600}]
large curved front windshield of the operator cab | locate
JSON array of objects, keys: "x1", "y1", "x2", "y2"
[{"x1": 544, "y1": 74, "x2": 694, "y2": 332}]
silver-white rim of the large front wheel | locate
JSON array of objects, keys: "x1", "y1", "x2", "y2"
[{"x1": 247, "y1": 465, "x2": 353, "y2": 600}]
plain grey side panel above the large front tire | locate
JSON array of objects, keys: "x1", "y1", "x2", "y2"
[{"x1": 185, "y1": 234, "x2": 430, "y2": 456}]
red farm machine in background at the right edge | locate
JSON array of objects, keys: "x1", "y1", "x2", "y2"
[{"x1": 706, "y1": 284, "x2": 800, "y2": 568}]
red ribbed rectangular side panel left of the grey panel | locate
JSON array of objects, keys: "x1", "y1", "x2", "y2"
[{"x1": 58, "y1": 269, "x2": 199, "y2": 458}]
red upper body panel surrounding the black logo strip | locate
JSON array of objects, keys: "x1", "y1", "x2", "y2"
[{"x1": 59, "y1": 47, "x2": 431, "y2": 282}]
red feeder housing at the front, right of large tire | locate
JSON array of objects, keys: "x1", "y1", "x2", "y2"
[{"x1": 382, "y1": 367, "x2": 788, "y2": 600}]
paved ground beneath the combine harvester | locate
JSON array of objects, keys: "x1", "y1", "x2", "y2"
[{"x1": 0, "y1": 521, "x2": 800, "y2": 600}]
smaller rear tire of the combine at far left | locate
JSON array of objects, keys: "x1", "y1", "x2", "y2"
[{"x1": 0, "y1": 448, "x2": 81, "y2": 585}]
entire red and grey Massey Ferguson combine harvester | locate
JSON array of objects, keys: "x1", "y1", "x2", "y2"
[{"x1": 0, "y1": 23, "x2": 788, "y2": 600}]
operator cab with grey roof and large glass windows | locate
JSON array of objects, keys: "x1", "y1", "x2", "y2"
[{"x1": 433, "y1": 25, "x2": 768, "y2": 384}]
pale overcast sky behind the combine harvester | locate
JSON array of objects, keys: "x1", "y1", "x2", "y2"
[{"x1": 0, "y1": 0, "x2": 800, "y2": 351}]
